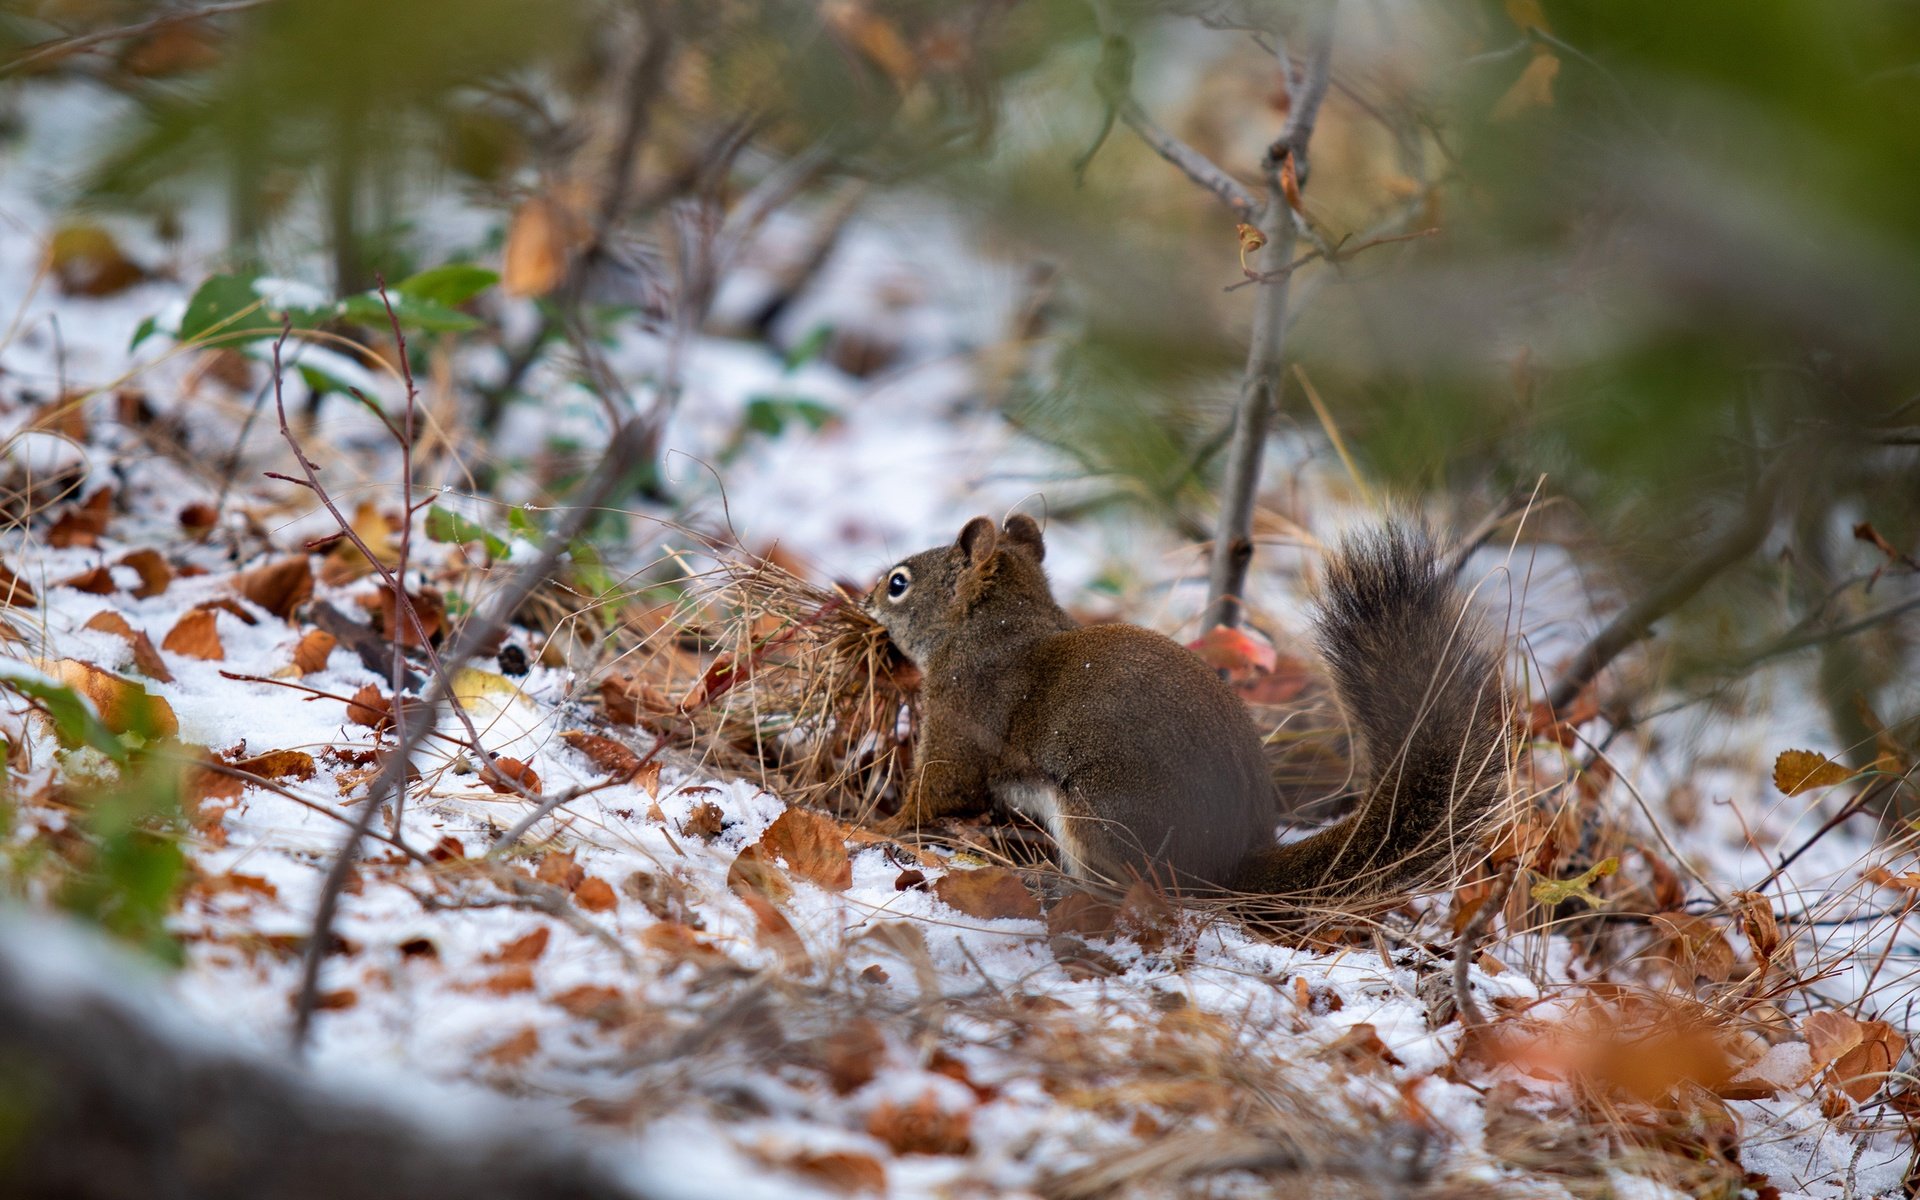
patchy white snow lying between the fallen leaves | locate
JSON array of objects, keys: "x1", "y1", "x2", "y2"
[{"x1": 0, "y1": 67, "x2": 1910, "y2": 1200}]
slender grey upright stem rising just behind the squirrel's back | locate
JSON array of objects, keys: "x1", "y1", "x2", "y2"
[{"x1": 1202, "y1": 0, "x2": 1338, "y2": 628}]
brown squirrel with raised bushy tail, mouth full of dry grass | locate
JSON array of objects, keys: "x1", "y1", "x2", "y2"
[{"x1": 864, "y1": 515, "x2": 1507, "y2": 900}]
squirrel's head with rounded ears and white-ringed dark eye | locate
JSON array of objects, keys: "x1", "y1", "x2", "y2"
[{"x1": 866, "y1": 513, "x2": 1052, "y2": 666}]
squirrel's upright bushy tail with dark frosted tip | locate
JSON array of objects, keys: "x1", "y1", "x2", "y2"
[{"x1": 1236, "y1": 524, "x2": 1507, "y2": 900}]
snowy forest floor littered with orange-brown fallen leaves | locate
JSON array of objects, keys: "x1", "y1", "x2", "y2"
[{"x1": 0, "y1": 82, "x2": 1920, "y2": 1200}]
